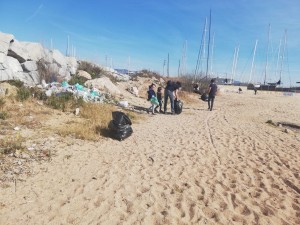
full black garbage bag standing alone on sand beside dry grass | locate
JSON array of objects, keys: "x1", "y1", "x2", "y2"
[{"x1": 108, "y1": 111, "x2": 133, "y2": 141}]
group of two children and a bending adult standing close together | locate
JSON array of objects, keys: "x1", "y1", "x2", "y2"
[{"x1": 147, "y1": 80, "x2": 181, "y2": 115}]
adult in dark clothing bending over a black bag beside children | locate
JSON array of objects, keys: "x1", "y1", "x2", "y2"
[{"x1": 164, "y1": 80, "x2": 181, "y2": 115}]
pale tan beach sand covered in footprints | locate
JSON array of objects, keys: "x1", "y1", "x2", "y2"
[{"x1": 0, "y1": 87, "x2": 300, "y2": 225}]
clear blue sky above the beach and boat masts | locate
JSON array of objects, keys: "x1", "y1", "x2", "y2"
[{"x1": 0, "y1": 0, "x2": 300, "y2": 86}]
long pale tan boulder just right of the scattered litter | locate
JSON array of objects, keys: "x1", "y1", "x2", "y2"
[{"x1": 85, "y1": 77, "x2": 121, "y2": 95}]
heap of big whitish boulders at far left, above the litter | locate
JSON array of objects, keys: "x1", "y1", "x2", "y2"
[{"x1": 0, "y1": 32, "x2": 78, "y2": 86}]
